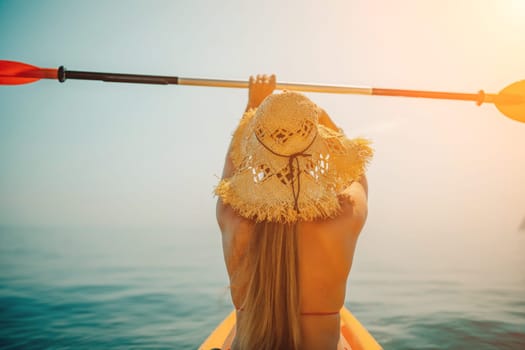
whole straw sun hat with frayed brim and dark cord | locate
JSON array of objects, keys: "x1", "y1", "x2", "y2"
[{"x1": 215, "y1": 92, "x2": 372, "y2": 223}]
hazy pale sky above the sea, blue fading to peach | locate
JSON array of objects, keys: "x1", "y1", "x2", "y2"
[{"x1": 0, "y1": 0, "x2": 525, "y2": 237}]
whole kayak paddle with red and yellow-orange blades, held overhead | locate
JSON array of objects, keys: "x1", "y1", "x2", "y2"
[{"x1": 0, "y1": 60, "x2": 525, "y2": 123}]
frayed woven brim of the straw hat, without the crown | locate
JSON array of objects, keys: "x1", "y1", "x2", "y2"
[{"x1": 215, "y1": 110, "x2": 373, "y2": 222}]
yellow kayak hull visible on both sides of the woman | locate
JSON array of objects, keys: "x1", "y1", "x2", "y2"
[{"x1": 199, "y1": 307, "x2": 382, "y2": 350}]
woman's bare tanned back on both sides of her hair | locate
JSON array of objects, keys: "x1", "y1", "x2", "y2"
[{"x1": 217, "y1": 177, "x2": 367, "y2": 349}]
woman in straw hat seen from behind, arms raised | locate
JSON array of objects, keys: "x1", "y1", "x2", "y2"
[{"x1": 215, "y1": 76, "x2": 372, "y2": 350}]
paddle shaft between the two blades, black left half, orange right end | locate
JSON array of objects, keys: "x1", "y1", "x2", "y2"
[{"x1": 58, "y1": 66, "x2": 496, "y2": 105}]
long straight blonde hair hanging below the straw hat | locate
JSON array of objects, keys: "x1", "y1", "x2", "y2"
[{"x1": 232, "y1": 222, "x2": 301, "y2": 350}]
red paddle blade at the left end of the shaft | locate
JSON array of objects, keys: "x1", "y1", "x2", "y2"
[{"x1": 0, "y1": 60, "x2": 58, "y2": 85}]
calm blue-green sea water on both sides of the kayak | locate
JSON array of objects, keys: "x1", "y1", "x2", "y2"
[{"x1": 0, "y1": 227, "x2": 525, "y2": 349}]
